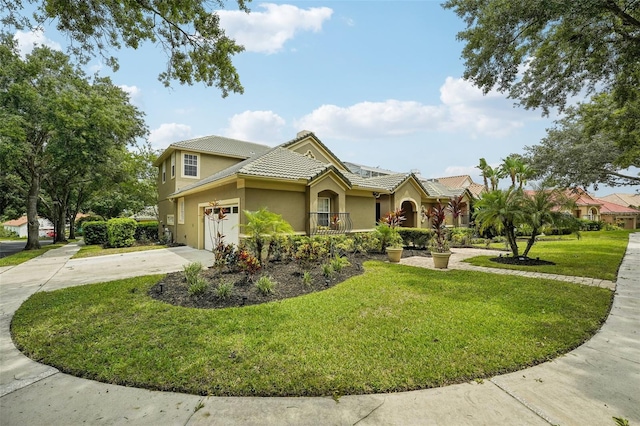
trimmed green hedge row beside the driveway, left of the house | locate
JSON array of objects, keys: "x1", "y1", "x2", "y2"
[{"x1": 82, "y1": 218, "x2": 158, "y2": 247}]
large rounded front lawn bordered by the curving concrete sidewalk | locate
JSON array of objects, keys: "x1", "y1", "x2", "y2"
[{"x1": 11, "y1": 262, "x2": 612, "y2": 396}]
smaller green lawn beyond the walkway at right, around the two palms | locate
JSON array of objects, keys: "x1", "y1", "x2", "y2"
[{"x1": 465, "y1": 230, "x2": 633, "y2": 281}]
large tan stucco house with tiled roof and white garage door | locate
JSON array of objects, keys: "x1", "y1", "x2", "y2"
[{"x1": 154, "y1": 131, "x2": 468, "y2": 250}]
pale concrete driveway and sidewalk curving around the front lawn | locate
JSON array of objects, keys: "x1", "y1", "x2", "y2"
[{"x1": 0, "y1": 233, "x2": 640, "y2": 426}]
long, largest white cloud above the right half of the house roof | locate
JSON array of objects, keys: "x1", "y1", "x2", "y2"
[{"x1": 295, "y1": 77, "x2": 540, "y2": 140}]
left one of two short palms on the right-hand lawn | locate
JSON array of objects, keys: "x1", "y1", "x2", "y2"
[{"x1": 474, "y1": 188, "x2": 524, "y2": 257}]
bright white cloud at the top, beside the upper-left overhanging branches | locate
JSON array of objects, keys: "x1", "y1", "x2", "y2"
[{"x1": 217, "y1": 3, "x2": 333, "y2": 54}]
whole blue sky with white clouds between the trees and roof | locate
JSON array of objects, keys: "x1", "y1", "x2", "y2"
[{"x1": 17, "y1": 1, "x2": 614, "y2": 194}]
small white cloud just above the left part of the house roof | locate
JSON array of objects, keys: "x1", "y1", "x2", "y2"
[{"x1": 225, "y1": 111, "x2": 285, "y2": 143}]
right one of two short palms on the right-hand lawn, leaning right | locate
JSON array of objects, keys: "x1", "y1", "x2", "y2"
[{"x1": 522, "y1": 186, "x2": 575, "y2": 257}]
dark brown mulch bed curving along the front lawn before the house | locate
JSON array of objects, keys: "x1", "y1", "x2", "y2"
[{"x1": 149, "y1": 249, "x2": 429, "y2": 309}]
